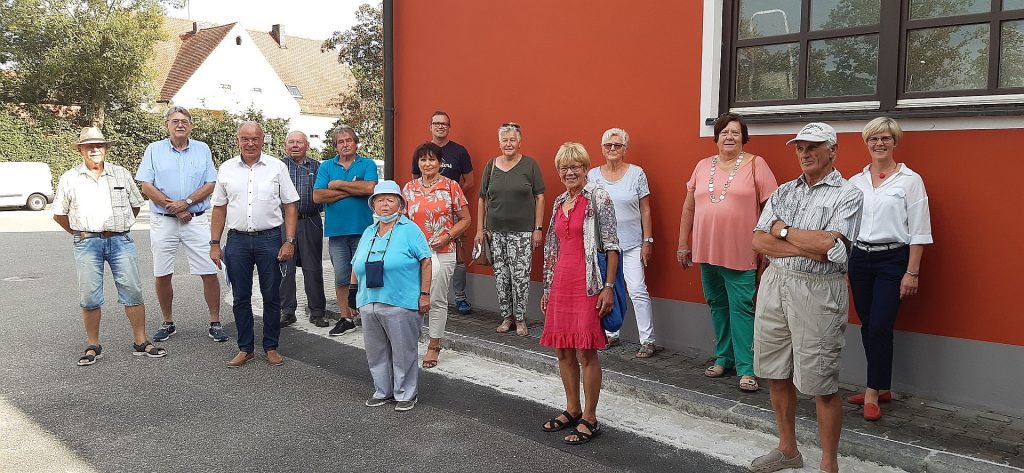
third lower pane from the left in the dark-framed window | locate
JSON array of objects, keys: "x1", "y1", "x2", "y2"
[{"x1": 906, "y1": 24, "x2": 989, "y2": 92}]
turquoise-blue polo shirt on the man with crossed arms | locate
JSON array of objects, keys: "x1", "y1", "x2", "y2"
[{"x1": 313, "y1": 155, "x2": 377, "y2": 237}]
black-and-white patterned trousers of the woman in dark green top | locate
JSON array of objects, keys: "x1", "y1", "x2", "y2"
[{"x1": 490, "y1": 231, "x2": 534, "y2": 321}]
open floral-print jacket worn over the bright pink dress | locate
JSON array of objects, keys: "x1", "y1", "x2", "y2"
[{"x1": 544, "y1": 182, "x2": 618, "y2": 297}]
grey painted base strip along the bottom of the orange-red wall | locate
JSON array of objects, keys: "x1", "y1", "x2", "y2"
[{"x1": 462, "y1": 273, "x2": 1024, "y2": 416}]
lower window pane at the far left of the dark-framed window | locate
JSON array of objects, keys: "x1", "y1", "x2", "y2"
[{"x1": 736, "y1": 43, "x2": 800, "y2": 101}]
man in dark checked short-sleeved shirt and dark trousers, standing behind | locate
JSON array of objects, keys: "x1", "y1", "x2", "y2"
[{"x1": 281, "y1": 131, "x2": 330, "y2": 327}]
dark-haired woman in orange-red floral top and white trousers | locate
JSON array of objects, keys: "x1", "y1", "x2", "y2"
[{"x1": 401, "y1": 141, "x2": 470, "y2": 369}]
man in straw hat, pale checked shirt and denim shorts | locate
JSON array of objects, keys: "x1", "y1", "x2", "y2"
[{"x1": 53, "y1": 128, "x2": 167, "y2": 367}]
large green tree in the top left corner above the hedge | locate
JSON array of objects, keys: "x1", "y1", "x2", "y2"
[{"x1": 0, "y1": 0, "x2": 163, "y2": 125}]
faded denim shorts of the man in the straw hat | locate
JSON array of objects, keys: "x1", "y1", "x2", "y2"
[{"x1": 74, "y1": 233, "x2": 144, "y2": 310}]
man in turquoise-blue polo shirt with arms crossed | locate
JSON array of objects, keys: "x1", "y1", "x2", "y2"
[{"x1": 313, "y1": 125, "x2": 377, "y2": 336}]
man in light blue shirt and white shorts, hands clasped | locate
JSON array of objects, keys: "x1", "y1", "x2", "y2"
[{"x1": 135, "y1": 106, "x2": 227, "y2": 342}]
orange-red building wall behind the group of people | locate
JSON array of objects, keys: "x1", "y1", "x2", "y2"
[{"x1": 394, "y1": 0, "x2": 1024, "y2": 345}]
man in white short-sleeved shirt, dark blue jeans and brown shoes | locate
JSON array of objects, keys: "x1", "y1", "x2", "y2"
[{"x1": 210, "y1": 122, "x2": 299, "y2": 368}]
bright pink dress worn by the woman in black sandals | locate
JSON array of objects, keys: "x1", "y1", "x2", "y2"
[{"x1": 541, "y1": 196, "x2": 607, "y2": 349}]
